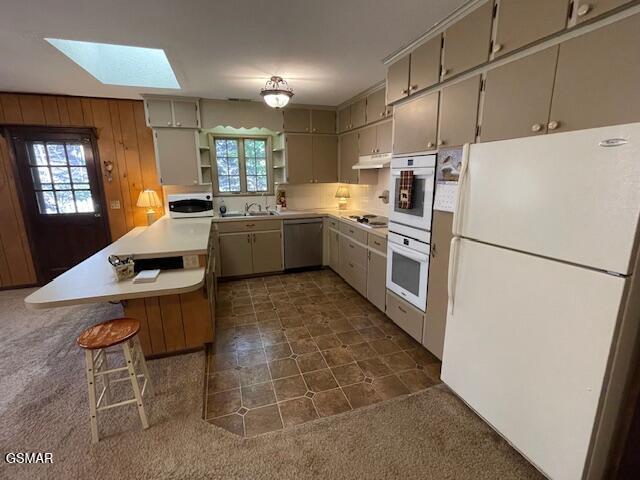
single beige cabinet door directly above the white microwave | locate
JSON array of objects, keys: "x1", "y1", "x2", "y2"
[{"x1": 153, "y1": 128, "x2": 200, "y2": 185}]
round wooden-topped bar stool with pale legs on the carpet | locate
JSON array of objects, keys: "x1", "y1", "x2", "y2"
[{"x1": 77, "y1": 318, "x2": 153, "y2": 443}]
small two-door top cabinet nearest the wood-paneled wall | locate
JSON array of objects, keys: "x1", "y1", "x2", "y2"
[{"x1": 144, "y1": 97, "x2": 200, "y2": 128}]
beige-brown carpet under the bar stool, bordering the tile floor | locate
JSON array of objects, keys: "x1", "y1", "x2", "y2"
[{"x1": 0, "y1": 290, "x2": 542, "y2": 480}]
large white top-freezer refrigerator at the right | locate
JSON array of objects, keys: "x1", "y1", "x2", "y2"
[{"x1": 442, "y1": 124, "x2": 640, "y2": 480}]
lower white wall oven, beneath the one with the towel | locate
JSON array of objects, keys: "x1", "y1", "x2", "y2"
[{"x1": 387, "y1": 230, "x2": 430, "y2": 312}]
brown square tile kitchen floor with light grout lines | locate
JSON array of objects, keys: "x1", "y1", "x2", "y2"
[{"x1": 205, "y1": 270, "x2": 440, "y2": 436}]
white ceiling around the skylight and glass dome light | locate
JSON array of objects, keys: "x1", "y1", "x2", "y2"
[{"x1": 0, "y1": 0, "x2": 466, "y2": 105}]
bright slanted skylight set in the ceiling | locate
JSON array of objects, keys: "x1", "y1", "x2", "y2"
[{"x1": 45, "y1": 38, "x2": 180, "y2": 89}]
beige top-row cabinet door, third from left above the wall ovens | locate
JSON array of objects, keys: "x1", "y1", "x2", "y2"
[{"x1": 442, "y1": 2, "x2": 493, "y2": 78}]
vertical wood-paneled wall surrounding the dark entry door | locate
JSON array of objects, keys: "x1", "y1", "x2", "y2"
[{"x1": 0, "y1": 93, "x2": 164, "y2": 288}]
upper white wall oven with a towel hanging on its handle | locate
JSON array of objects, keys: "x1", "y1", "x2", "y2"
[{"x1": 389, "y1": 155, "x2": 436, "y2": 230}]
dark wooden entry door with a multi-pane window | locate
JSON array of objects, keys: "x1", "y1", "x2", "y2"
[{"x1": 7, "y1": 127, "x2": 111, "y2": 284}]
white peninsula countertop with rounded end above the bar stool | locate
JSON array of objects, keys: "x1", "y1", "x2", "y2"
[{"x1": 25, "y1": 217, "x2": 211, "y2": 309}]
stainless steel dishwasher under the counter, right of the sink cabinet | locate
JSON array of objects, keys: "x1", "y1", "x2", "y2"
[{"x1": 283, "y1": 218, "x2": 322, "y2": 270}]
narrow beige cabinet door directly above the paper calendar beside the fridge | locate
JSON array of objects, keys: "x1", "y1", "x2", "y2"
[{"x1": 438, "y1": 75, "x2": 480, "y2": 147}]
